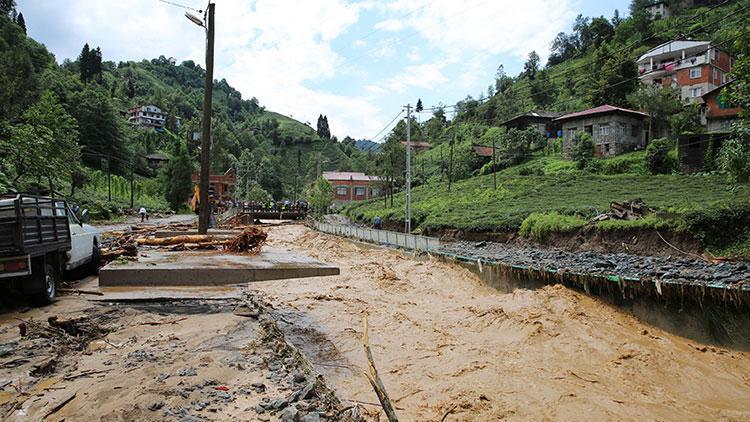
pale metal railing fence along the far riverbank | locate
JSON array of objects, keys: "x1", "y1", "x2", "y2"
[{"x1": 314, "y1": 221, "x2": 440, "y2": 252}]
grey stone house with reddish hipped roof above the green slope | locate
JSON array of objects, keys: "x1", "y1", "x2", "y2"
[{"x1": 554, "y1": 104, "x2": 648, "y2": 158}]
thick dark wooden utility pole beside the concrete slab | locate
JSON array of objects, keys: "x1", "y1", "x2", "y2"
[{"x1": 198, "y1": 3, "x2": 216, "y2": 234}]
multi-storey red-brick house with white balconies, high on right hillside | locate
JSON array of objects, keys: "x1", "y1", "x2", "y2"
[{"x1": 637, "y1": 41, "x2": 734, "y2": 102}]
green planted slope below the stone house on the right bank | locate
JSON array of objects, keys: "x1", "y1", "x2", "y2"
[{"x1": 346, "y1": 152, "x2": 750, "y2": 236}]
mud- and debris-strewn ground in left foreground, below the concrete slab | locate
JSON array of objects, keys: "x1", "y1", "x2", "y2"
[{"x1": 0, "y1": 296, "x2": 356, "y2": 421}]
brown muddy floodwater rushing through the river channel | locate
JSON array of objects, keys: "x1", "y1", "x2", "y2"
[{"x1": 251, "y1": 225, "x2": 750, "y2": 420}]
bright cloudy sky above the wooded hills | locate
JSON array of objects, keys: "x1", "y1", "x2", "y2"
[{"x1": 22, "y1": 0, "x2": 630, "y2": 141}]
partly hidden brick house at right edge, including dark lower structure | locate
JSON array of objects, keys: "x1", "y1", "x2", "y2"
[{"x1": 677, "y1": 81, "x2": 742, "y2": 173}]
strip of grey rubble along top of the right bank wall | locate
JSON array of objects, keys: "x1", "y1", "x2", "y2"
[{"x1": 440, "y1": 242, "x2": 750, "y2": 286}]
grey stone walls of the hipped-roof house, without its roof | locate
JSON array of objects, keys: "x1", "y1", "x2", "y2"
[{"x1": 562, "y1": 114, "x2": 645, "y2": 159}]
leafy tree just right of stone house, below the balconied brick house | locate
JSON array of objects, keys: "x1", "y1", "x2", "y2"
[{"x1": 628, "y1": 84, "x2": 683, "y2": 140}]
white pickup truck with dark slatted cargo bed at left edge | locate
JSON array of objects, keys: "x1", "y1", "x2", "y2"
[{"x1": 0, "y1": 193, "x2": 101, "y2": 305}]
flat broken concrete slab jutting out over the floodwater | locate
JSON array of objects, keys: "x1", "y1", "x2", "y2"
[{"x1": 99, "y1": 248, "x2": 340, "y2": 287}]
